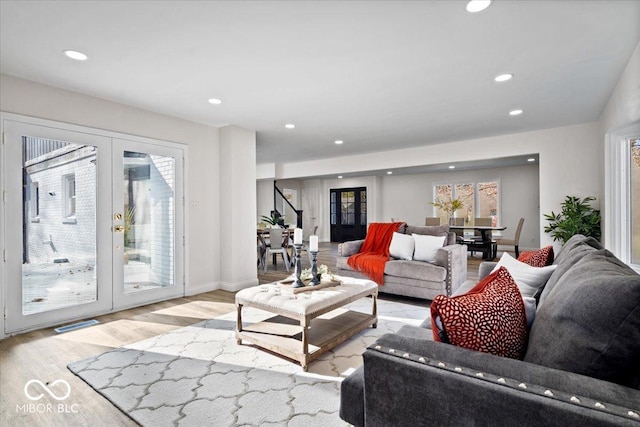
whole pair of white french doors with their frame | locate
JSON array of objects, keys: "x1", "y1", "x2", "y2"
[{"x1": 2, "y1": 120, "x2": 184, "y2": 333}]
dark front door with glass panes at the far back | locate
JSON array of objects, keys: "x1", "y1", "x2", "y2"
[{"x1": 329, "y1": 187, "x2": 367, "y2": 242}]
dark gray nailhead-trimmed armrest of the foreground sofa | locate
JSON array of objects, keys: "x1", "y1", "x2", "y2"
[{"x1": 363, "y1": 334, "x2": 640, "y2": 427}]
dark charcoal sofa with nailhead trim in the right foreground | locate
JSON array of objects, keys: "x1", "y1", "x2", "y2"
[{"x1": 340, "y1": 235, "x2": 640, "y2": 427}]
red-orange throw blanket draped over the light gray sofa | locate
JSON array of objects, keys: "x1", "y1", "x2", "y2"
[{"x1": 347, "y1": 222, "x2": 404, "y2": 286}]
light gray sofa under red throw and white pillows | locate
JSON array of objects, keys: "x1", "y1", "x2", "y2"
[{"x1": 336, "y1": 224, "x2": 467, "y2": 299}]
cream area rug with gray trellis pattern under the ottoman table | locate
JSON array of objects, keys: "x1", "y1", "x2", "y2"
[{"x1": 68, "y1": 299, "x2": 428, "y2": 427}]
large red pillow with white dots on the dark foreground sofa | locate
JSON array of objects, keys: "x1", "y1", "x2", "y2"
[{"x1": 431, "y1": 267, "x2": 528, "y2": 359}]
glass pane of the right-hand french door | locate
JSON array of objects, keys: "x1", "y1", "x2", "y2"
[{"x1": 123, "y1": 151, "x2": 175, "y2": 293}]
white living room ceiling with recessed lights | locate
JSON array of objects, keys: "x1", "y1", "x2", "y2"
[{"x1": 0, "y1": 0, "x2": 640, "y2": 167}]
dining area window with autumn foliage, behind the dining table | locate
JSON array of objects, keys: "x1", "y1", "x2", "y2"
[{"x1": 434, "y1": 181, "x2": 500, "y2": 226}]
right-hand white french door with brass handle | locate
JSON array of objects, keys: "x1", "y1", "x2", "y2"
[{"x1": 112, "y1": 139, "x2": 184, "y2": 309}]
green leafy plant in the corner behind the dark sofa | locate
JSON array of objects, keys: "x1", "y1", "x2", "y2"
[{"x1": 544, "y1": 196, "x2": 601, "y2": 243}]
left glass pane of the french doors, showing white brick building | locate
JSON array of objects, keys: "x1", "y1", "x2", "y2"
[{"x1": 22, "y1": 136, "x2": 98, "y2": 315}]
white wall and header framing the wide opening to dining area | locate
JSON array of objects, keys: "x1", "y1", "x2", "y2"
[{"x1": 258, "y1": 122, "x2": 603, "y2": 246}]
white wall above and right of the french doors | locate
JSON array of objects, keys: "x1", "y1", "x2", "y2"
[{"x1": 0, "y1": 75, "x2": 222, "y2": 300}]
